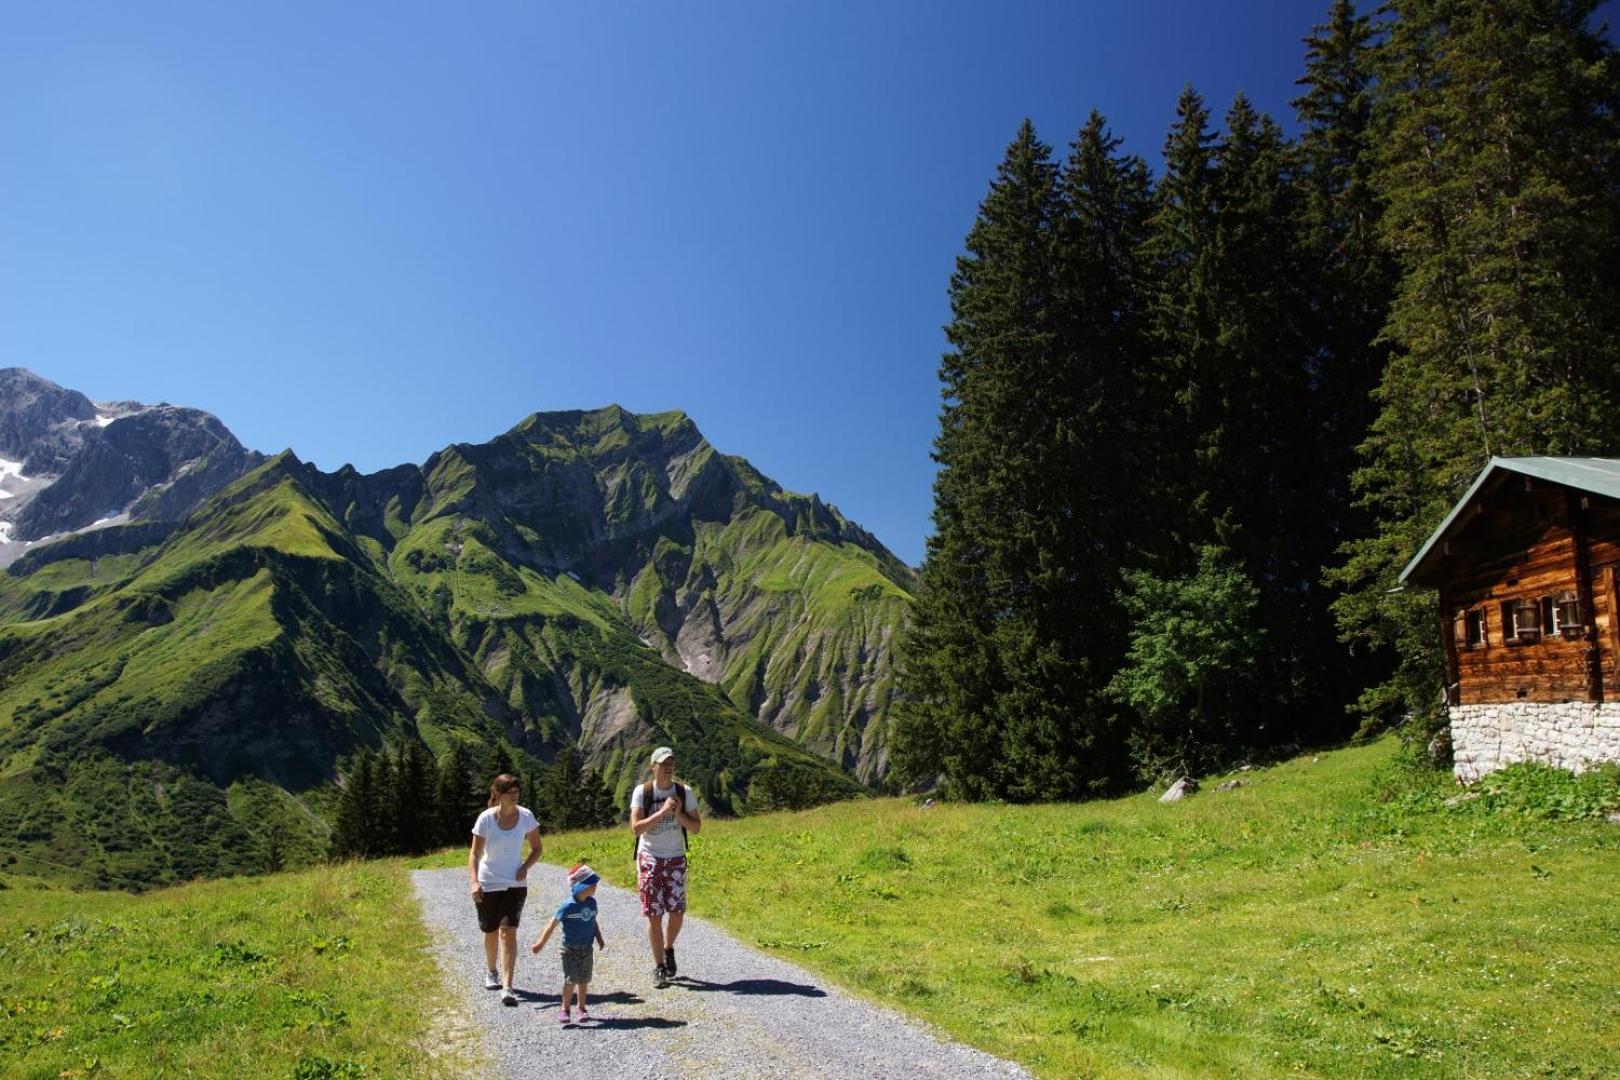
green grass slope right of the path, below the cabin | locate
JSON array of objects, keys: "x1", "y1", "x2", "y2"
[{"x1": 492, "y1": 742, "x2": 1620, "y2": 1078}]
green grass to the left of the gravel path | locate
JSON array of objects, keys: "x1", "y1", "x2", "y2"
[{"x1": 0, "y1": 863, "x2": 471, "y2": 1080}]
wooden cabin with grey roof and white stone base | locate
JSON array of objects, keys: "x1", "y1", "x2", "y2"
[{"x1": 1401, "y1": 458, "x2": 1620, "y2": 780}]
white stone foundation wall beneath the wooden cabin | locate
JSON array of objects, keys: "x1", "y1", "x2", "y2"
[{"x1": 1450, "y1": 701, "x2": 1620, "y2": 784}]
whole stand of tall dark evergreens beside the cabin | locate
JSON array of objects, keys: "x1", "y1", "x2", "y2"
[{"x1": 891, "y1": 0, "x2": 1620, "y2": 801}]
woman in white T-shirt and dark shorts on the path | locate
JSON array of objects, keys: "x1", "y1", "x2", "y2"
[{"x1": 467, "y1": 772, "x2": 541, "y2": 1006}]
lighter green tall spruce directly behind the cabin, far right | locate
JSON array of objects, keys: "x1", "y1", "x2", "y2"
[{"x1": 1337, "y1": 0, "x2": 1620, "y2": 731}]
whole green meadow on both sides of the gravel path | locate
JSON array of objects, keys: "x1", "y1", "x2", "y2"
[{"x1": 0, "y1": 740, "x2": 1620, "y2": 1080}]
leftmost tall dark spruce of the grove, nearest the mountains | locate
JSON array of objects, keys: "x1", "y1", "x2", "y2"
[{"x1": 891, "y1": 120, "x2": 1061, "y2": 798}]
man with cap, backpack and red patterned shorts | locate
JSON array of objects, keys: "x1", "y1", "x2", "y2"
[{"x1": 630, "y1": 746, "x2": 703, "y2": 986}]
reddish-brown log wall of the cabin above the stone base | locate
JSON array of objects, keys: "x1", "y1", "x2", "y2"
[{"x1": 1440, "y1": 483, "x2": 1620, "y2": 704}]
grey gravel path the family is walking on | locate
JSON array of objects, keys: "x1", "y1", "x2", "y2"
[{"x1": 411, "y1": 863, "x2": 1027, "y2": 1080}]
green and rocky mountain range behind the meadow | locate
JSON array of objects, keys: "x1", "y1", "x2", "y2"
[{"x1": 0, "y1": 369, "x2": 914, "y2": 879}]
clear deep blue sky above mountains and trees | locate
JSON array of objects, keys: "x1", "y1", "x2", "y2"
[{"x1": 0, "y1": 0, "x2": 1380, "y2": 563}]
